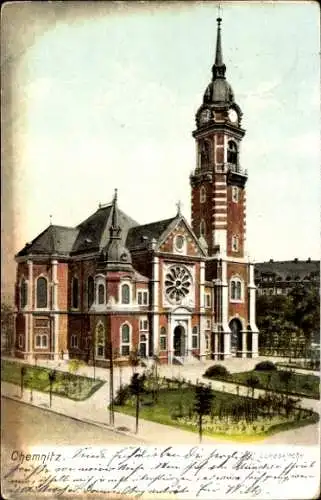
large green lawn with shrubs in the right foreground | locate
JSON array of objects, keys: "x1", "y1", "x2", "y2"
[{"x1": 114, "y1": 378, "x2": 319, "y2": 441}]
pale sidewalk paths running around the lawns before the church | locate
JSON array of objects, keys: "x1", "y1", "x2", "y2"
[{"x1": 1, "y1": 358, "x2": 320, "y2": 445}]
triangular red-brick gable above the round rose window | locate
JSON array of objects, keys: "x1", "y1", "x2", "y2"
[{"x1": 157, "y1": 218, "x2": 204, "y2": 257}]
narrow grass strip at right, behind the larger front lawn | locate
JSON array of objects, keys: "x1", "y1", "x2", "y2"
[{"x1": 202, "y1": 370, "x2": 320, "y2": 399}]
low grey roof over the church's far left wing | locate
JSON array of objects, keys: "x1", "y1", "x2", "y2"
[{"x1": 16, "y1": 225, "x2": 78, "y2": 257}]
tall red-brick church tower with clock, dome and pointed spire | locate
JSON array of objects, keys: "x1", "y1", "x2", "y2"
[{"x1": 190, "y1": 17, "x2": 258, "y2": 358}]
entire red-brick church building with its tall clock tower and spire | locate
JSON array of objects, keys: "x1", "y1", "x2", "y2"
[{"x1": 13, "y1": 18, "x2": 258, "y2": 366}]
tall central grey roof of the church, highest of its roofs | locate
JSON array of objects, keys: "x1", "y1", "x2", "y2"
[{"x1": 71, "y1": 204, "x2": 138, "y2": 254}]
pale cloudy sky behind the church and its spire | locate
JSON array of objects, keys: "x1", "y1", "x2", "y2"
[{"x1": 2, "y1": 1, "x2": 320, "y2": 296}]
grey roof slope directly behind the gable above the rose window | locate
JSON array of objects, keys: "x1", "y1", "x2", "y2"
[{"x1": 126, "y1": 217, "x2": 176, "y2": 250}]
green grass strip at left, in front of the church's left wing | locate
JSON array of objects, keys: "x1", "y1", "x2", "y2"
[{"x1": 1, "y1": 360, "x2": 105, "y2": 401}]
